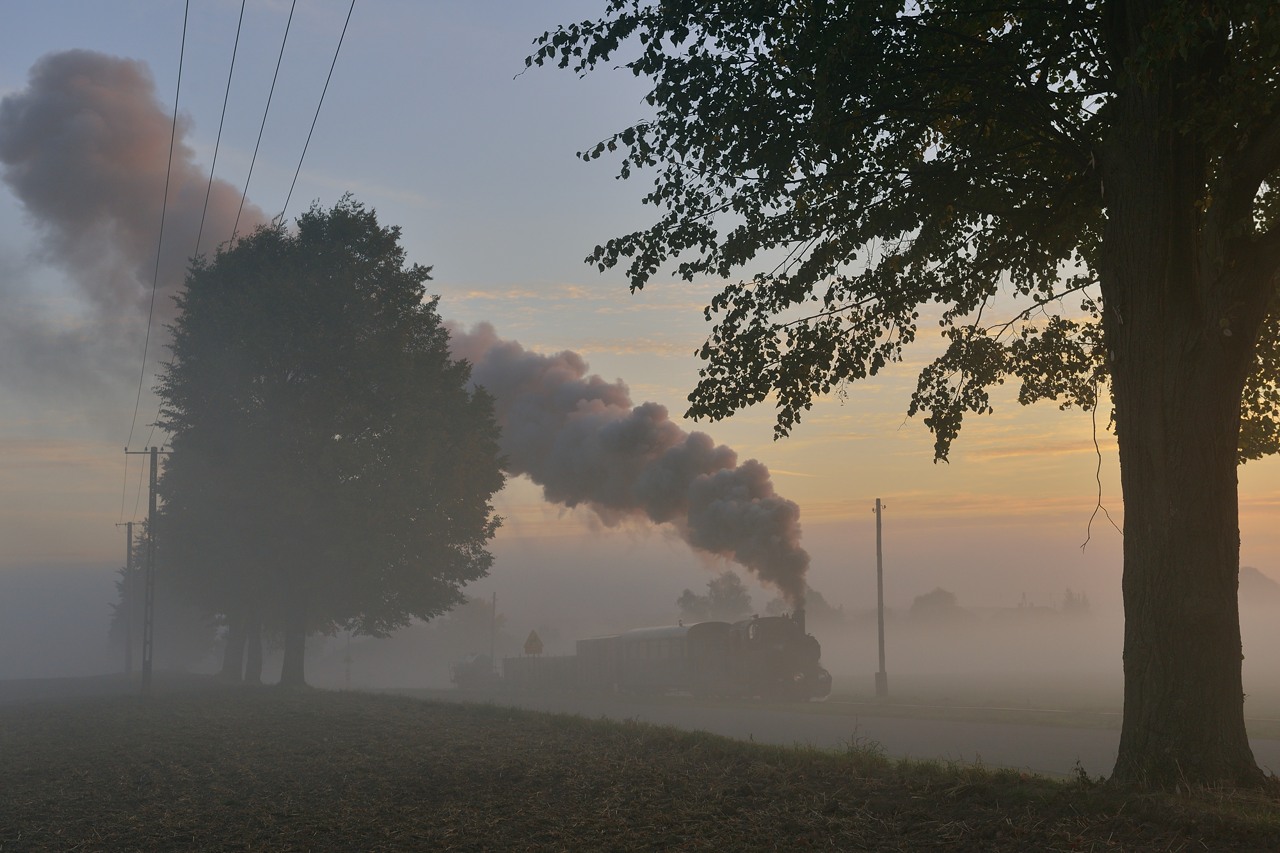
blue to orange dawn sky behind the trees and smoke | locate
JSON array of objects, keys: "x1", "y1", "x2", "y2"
[{"x1": 0, "y1": 0, "x2": 1280, "y2": 671}]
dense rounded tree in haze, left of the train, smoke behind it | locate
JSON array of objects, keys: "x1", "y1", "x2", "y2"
[{"x1": 159, "y1": 197, "x2": 503, "y2": 684}]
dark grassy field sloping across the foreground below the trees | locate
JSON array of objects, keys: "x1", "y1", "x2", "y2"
[{"x1": 0, "y1": 688, "x2": 1280, "y2": 852}]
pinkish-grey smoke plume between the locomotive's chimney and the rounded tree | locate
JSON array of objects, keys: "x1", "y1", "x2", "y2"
[{"x1": 449, "y1": 323, "x2": 809, "y2": 605}]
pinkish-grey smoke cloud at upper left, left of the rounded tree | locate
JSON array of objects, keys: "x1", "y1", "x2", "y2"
[{"x1": 0, "y1": 50, "x2": 265, "y2": 397}]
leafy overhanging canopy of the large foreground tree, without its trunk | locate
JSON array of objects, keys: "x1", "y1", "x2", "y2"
[{"x1": 526, "y1": 0, "x2": 1280, "y2": 460}]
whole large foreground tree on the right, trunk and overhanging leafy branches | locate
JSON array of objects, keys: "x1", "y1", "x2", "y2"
[{"x1": 526, "y1": 0, "x2": 1280, "y2": 785}]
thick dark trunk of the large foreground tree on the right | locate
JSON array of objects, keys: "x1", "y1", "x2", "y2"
[{"x1": 1101, "y1": 0, "x2": 1263, "y2": 788}]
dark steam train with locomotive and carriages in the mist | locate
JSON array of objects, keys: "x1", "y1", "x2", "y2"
[{"x1": 502, "y1": 610, "x2": 831, "y2": 701}]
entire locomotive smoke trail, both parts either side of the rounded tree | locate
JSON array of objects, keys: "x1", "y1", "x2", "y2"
[{"x1": 0, "y1": 50, "x2": 809, "y2": 605}]
